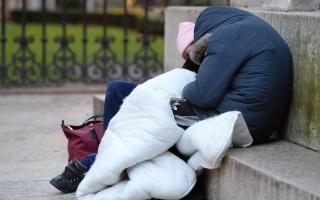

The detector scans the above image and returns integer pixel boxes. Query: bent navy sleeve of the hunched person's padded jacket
[183,31,248,108]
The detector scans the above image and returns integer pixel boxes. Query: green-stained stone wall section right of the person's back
[252,11,320,150]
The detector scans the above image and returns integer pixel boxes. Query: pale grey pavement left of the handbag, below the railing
[0,94,102,200]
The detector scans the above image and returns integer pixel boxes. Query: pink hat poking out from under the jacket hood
[177,22,194,57]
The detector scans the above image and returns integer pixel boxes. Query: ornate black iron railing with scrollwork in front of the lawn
[0,0,210,87]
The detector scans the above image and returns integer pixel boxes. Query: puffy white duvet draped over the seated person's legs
[77,69,252,200]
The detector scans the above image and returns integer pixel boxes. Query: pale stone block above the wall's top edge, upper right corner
[263,0,320,11]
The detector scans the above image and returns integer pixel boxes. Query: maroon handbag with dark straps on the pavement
[61,115,104,162]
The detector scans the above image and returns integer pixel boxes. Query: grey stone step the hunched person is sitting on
[93,95,320,200]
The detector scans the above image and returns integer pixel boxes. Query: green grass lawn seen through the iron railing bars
[6,22,164,66]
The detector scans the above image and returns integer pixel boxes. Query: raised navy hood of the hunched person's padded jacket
[194,7,251,41]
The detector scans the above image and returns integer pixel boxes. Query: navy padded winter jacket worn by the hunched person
[184,7,292,143]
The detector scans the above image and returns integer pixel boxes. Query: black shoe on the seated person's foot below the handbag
[50,160,88,193]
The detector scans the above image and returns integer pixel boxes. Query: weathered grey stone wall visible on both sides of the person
[164,5,320,150]
